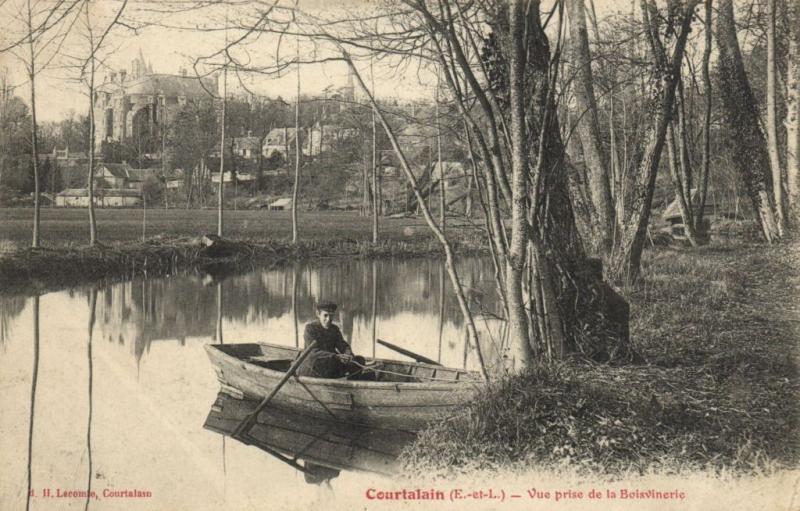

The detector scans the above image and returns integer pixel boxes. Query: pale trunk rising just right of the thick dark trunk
[567,0,615,256]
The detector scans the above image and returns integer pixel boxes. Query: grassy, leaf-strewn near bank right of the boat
[404,245,800,474]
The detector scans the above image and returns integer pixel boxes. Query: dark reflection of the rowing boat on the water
[204,392,415,482]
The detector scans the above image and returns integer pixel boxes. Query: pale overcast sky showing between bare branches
[0,0,631,121]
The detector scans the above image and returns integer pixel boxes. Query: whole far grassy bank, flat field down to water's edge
[0,208,482,294]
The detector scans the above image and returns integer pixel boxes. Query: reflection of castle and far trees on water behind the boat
[86,260,495,367]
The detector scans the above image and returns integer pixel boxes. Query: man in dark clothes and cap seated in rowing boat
[297,301,365,379]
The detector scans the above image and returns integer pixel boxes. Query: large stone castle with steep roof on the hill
[94,51,217,152]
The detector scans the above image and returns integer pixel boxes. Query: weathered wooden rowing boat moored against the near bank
[206,344,482,431]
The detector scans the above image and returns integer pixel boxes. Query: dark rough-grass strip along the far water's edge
[0,236,483,295]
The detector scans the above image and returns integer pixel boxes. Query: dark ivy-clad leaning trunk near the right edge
[717,0,780,243]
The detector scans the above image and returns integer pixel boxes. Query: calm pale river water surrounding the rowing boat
[0,259,498,509]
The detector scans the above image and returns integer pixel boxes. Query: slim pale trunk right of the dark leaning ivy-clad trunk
[767,0,785,236]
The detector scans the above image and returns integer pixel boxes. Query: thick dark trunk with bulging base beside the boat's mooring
[527,19,632,361]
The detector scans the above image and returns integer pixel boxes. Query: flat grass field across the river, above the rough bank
[0,208,450,247]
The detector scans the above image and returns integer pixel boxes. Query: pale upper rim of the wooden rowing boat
[204,343,484,391]
